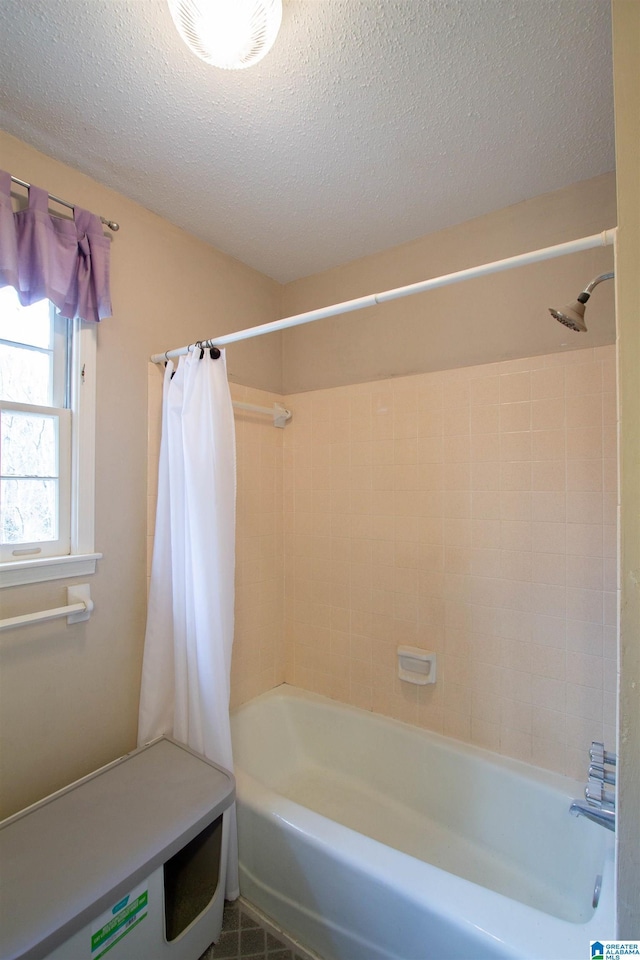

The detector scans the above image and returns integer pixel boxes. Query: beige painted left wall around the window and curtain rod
[0,133,281,815]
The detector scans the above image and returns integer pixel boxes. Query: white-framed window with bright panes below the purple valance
[0,287,98,586]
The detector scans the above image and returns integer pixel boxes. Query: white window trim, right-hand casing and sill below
[0,320,102,588]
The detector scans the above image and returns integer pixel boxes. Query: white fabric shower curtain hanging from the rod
[138,351,238,899]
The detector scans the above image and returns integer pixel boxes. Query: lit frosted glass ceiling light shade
[168,0,282,70]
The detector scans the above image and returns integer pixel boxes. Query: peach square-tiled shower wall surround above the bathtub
[150,346,617,779]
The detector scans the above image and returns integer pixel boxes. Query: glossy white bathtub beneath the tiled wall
[232,685,614,960]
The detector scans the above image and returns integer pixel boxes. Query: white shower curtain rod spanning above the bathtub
[151,227,616,363]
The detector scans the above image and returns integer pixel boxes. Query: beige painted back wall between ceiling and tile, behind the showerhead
[283,174,616,393]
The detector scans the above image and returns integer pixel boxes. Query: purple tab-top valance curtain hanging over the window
[0,170,111,321]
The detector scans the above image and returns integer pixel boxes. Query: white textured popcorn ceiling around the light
[0,0,614,282]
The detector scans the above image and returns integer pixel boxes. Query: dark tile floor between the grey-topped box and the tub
[200,900,312,960]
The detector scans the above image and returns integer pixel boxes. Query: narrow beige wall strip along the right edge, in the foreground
[612,0,640,940]
